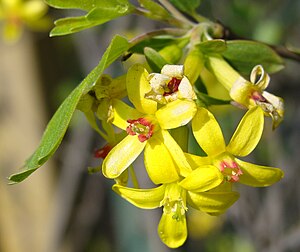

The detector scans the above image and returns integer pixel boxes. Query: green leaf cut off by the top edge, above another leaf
[45,0,129,11]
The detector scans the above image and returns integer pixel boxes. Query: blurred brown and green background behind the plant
[0,0,300,252]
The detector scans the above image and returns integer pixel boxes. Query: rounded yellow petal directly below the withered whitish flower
[155,99,197,129]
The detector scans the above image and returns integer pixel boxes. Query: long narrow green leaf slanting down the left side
[9,35,129,183]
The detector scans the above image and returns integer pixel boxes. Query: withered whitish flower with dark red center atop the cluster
[145,65,197,104]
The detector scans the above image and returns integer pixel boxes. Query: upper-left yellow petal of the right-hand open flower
[192,108,225,156]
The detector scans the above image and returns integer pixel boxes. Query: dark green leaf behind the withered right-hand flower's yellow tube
[222,40,284,75]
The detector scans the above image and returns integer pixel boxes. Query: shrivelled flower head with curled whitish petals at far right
[230,65,284,128]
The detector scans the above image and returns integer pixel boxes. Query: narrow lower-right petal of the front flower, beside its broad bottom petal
[161,130,192,177]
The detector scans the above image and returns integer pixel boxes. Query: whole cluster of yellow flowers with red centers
[80,61,283,248]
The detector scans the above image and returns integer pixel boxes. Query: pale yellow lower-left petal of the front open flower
[102,135,147,178]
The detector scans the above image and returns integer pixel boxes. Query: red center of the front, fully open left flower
[126,118,154,142]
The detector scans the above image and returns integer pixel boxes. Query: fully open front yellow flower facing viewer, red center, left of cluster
[102,65,197,184]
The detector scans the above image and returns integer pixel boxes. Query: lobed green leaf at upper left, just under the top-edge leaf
[50,1,133,37]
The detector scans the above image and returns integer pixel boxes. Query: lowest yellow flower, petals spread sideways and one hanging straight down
[113,177,239,248]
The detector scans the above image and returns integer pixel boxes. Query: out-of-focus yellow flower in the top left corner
[0,0,50,42]
